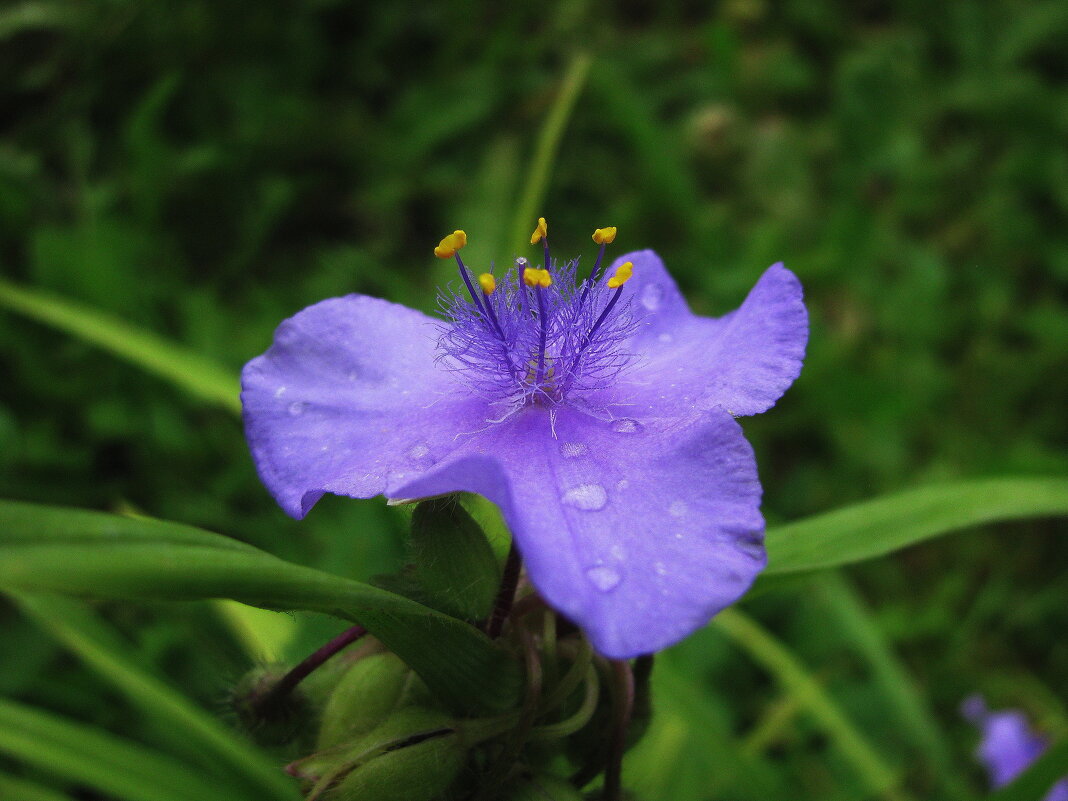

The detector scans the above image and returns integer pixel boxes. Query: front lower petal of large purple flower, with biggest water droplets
[391,407,766,659]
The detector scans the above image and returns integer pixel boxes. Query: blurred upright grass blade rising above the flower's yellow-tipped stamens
[512,52,593,252]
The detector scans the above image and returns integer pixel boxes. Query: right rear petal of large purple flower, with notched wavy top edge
[613,250,808,415]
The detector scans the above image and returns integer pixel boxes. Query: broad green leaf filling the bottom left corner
[0,698,234,801]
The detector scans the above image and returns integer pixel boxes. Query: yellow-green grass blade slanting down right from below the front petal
[712,609,909,801]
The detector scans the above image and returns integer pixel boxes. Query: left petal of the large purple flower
[241,295,489,518]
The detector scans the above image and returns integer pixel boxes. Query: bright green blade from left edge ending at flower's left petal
[0,279,241,414]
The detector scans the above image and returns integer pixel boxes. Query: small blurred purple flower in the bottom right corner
[961,695,1068,801]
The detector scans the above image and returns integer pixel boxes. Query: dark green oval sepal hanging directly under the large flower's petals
[411,498,501,621]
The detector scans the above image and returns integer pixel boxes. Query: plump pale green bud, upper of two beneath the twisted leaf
[318,653,426,751]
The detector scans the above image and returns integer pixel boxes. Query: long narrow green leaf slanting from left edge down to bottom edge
[13,593,297,799]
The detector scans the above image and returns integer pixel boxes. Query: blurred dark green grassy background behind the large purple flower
[0,0,1068,801]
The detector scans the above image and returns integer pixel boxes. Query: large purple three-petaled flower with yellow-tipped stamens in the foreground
[241,219,808,658]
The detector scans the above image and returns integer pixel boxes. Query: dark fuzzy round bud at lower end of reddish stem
[230,664,312,745]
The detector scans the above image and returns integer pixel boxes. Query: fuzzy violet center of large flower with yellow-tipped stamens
[435,218,638,413]
